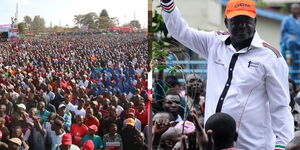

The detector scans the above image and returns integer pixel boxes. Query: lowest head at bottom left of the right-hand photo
[159,127,181,150]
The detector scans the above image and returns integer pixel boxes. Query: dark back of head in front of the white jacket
[205,113,238,149]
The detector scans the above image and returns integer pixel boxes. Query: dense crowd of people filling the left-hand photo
[0,32,149,150]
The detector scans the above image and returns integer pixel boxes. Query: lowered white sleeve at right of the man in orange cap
[266,57,294,149]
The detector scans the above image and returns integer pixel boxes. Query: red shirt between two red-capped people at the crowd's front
[71,123,88,147]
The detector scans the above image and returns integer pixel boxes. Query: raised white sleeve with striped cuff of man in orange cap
[161,0,216,59]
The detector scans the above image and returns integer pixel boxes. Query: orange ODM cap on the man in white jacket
[225,0,256,19]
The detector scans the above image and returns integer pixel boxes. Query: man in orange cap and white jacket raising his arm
[161,0,294,150]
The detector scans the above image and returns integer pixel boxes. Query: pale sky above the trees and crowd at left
[0,0,148,27]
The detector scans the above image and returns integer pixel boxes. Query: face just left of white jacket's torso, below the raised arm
[186,74,202,99]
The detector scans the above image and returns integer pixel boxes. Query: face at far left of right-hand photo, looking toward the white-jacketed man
[162,90,180,118]
